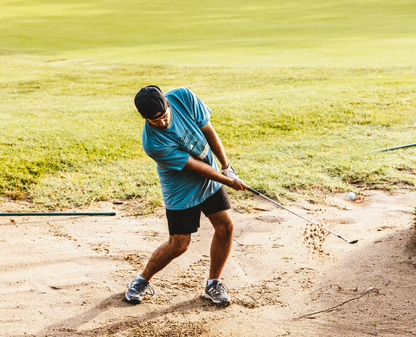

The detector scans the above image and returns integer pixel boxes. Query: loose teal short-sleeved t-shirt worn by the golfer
[142,88,221,210]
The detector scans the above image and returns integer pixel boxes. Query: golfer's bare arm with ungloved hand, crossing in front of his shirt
[184,156,249,191]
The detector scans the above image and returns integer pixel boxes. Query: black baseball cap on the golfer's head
[134,85,168,119]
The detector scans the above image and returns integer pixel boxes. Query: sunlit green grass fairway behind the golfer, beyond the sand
[0,0,416,209]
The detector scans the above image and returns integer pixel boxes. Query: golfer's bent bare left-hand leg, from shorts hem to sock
[140,234,191,281]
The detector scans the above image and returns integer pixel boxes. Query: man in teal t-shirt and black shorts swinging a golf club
[126,85,248,305]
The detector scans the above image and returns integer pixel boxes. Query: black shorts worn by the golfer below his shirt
[166,186,231,235]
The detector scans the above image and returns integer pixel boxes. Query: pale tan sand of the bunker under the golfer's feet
[0,191,416,337]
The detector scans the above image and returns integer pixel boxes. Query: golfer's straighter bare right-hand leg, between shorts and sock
[208,209,234,280]
